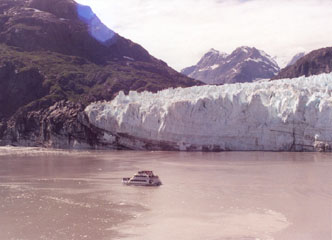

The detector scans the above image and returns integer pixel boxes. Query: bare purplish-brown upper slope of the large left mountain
[0,0,157,63]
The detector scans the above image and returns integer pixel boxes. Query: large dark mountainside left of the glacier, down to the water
[0,0,202,147]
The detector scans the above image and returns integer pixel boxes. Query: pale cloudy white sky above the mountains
[77,0,332,71]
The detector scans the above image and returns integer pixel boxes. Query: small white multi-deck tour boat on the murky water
[122,171,161,186]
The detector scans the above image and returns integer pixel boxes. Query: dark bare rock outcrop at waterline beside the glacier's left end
[0,100,121,149]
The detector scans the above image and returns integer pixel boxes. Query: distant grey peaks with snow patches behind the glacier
[181,47,280,84]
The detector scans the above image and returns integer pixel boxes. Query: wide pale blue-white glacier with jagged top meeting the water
[85,73,332,151]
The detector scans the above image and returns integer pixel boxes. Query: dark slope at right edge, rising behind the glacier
[273,47,332,79]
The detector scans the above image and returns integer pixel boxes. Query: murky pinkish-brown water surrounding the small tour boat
[0,148,332,240]
